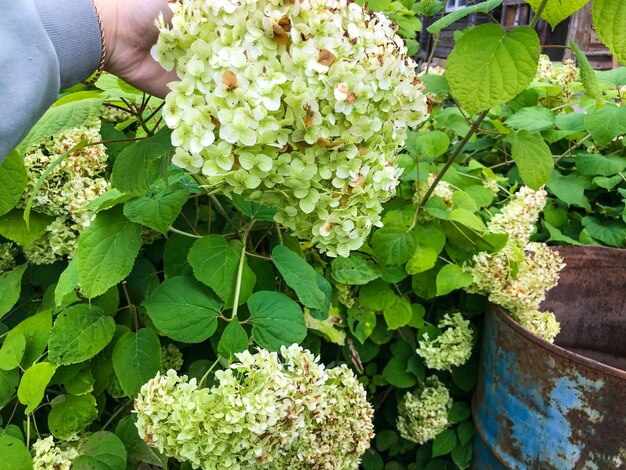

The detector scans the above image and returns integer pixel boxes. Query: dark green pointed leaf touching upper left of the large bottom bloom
[113,328,161,397]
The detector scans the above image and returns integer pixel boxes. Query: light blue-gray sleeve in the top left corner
[0,0,101,162]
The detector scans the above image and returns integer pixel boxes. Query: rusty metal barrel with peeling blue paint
[472,247,626,470]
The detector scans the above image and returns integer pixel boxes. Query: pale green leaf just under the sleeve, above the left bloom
[17,98,104,154]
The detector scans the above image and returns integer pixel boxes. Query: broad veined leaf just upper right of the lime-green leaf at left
[48,304,115,365]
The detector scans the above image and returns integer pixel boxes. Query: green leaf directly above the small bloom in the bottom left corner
[48,393,98,440]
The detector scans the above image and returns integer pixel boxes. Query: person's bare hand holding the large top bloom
[95,0,178,98]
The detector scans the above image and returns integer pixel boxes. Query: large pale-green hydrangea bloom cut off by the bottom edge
[135,345,373,469]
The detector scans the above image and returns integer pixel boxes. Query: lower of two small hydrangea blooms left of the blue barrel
[396,375,452,444]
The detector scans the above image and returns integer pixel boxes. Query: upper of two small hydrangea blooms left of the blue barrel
[417,312,474,371]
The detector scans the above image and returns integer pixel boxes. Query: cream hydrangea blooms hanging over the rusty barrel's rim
[466,187,565,341]
